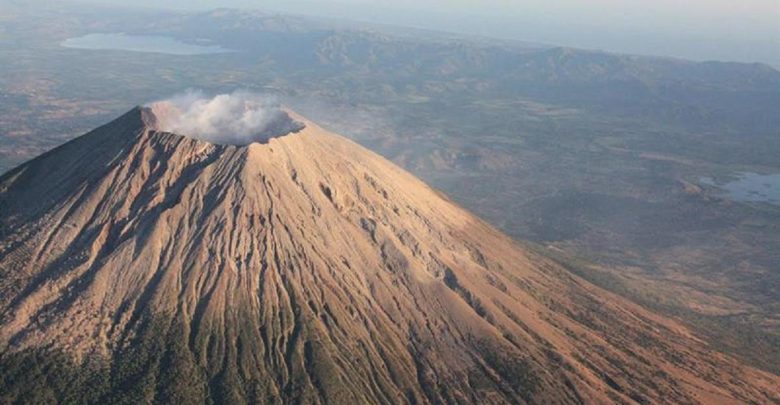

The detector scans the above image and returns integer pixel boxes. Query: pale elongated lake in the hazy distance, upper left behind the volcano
[60,33,233,55]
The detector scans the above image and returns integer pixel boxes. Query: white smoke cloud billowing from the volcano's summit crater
[147,90,304,145]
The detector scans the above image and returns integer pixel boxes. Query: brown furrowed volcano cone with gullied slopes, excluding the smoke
[0,108,780,403]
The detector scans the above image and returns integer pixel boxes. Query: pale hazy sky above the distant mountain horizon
[96,0,780,66]
